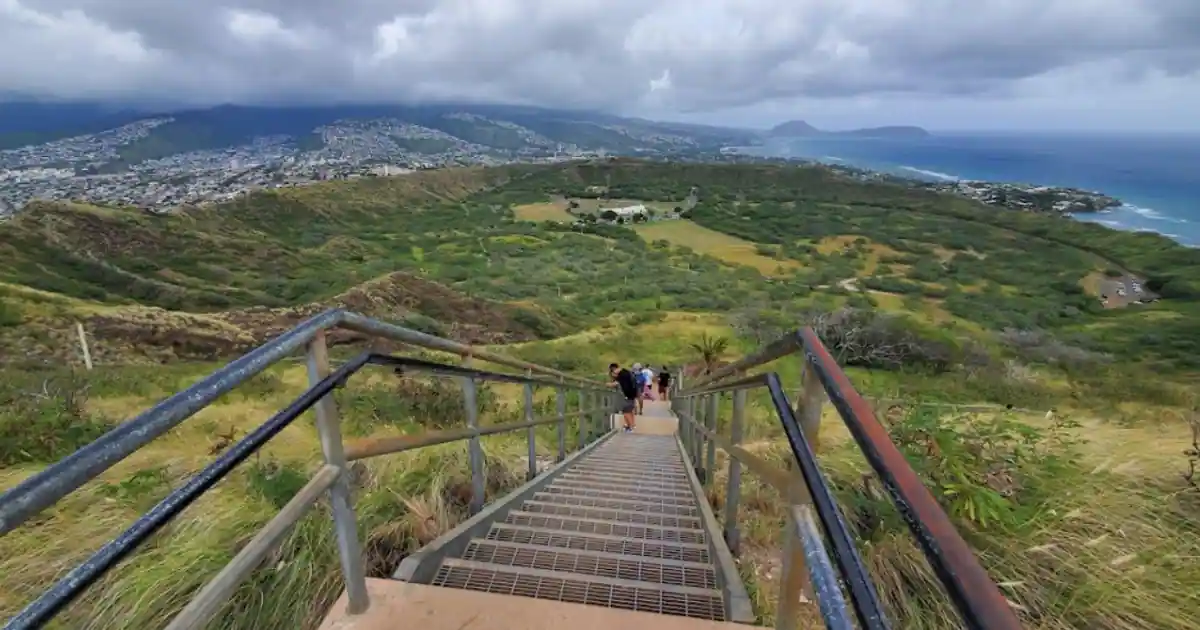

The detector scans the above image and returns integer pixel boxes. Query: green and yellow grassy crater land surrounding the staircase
[0,160,1200,630]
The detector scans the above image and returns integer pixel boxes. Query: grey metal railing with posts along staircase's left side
[0,310,616,630]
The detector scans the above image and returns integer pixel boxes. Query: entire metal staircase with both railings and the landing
[0,310,1020,630]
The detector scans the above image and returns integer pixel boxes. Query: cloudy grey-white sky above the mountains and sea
[0,0,1200,131]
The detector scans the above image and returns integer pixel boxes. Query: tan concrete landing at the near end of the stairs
[320,580,746,630]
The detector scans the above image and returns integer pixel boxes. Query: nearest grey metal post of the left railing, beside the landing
[306,330,371,614]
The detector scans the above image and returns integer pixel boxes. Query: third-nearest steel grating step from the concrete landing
[487,523,709,563]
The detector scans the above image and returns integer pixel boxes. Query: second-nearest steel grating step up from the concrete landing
[462,539,716,589]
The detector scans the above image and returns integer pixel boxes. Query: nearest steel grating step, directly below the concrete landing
[433,559,725,620]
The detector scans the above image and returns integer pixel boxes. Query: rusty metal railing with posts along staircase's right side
[672,328,1021,630]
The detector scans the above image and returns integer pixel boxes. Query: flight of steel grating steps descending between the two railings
[397,433,752,620]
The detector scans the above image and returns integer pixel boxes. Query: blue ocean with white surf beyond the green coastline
[755,133,1200,247]
